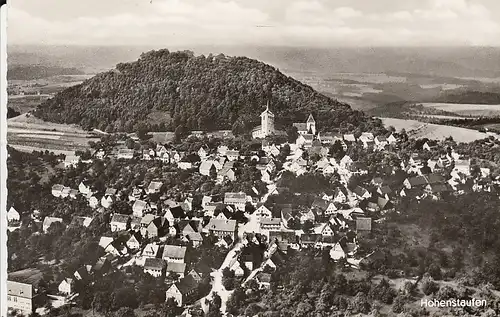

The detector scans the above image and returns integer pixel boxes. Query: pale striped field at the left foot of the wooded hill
[7,114,99,154]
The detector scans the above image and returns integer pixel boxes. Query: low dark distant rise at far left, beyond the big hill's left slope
[7,65,85,80]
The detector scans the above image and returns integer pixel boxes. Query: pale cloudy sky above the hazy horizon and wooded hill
[8,0,500,47]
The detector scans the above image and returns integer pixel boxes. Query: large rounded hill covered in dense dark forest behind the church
[35,49,366,131]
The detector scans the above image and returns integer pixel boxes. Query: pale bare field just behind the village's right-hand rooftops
[380,118,489,142]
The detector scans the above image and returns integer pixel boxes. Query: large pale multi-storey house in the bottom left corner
[6,278,38,316]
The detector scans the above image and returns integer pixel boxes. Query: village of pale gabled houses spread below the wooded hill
[7,105,500,315]
